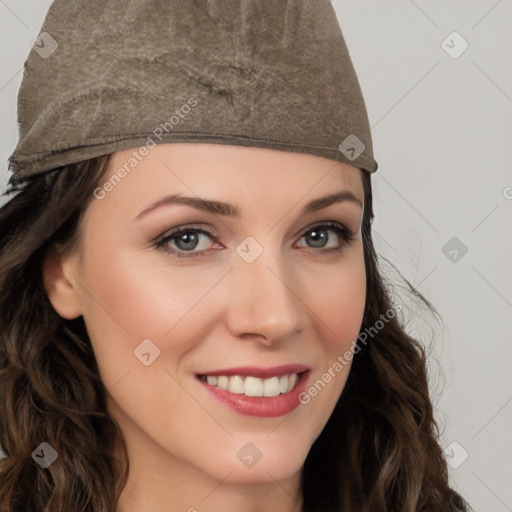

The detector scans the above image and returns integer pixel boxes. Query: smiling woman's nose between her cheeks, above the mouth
[227,246,304,346]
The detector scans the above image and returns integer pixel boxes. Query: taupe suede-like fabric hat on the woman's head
[10,0,378,179]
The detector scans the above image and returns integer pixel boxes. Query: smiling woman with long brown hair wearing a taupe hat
[0,0,472,512]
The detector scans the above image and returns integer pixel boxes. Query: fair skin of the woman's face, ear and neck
[44,143,366,512]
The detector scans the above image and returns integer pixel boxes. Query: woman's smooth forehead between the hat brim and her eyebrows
[103,143,365,200]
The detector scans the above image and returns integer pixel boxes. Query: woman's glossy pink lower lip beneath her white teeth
[196,370,311,418]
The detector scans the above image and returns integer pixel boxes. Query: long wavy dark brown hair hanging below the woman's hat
[0,156,467,512]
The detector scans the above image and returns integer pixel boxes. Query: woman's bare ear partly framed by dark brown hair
[42,246,82,320]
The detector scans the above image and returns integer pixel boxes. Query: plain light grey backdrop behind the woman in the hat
[0,0,512,512]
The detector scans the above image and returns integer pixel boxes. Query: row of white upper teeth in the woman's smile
[201,373,298,397]
